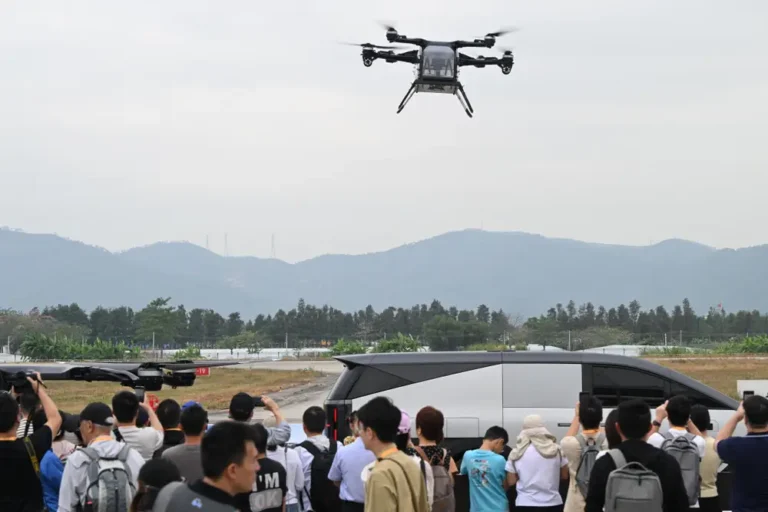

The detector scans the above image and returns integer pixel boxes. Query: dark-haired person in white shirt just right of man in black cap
[112,391,164,461]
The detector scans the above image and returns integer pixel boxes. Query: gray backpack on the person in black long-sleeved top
[605,449,664,512]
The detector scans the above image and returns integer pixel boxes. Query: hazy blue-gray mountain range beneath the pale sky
[0,230,768,317]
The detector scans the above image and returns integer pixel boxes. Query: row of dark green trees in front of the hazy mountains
[0,298,768,350]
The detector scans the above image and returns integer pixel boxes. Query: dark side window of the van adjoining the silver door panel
[592,365,667,407]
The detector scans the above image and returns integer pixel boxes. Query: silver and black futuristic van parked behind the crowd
[325,352,743,456]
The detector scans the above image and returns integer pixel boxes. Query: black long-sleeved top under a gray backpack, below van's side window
[584,439,690,512]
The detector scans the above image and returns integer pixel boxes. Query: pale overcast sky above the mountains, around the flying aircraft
[0,0,768,261]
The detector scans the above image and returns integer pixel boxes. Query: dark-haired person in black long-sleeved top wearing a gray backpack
[584,399,690,512]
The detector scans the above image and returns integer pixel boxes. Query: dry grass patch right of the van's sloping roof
[648,357,768,399]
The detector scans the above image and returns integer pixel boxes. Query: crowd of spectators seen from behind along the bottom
[0,375,768,512]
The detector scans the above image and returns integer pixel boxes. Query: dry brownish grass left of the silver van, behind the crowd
[48,368,321,412]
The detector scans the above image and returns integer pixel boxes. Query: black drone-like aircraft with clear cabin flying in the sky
[345,25,515,117]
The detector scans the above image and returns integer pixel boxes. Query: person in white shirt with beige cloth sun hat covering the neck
[505,414,569,512]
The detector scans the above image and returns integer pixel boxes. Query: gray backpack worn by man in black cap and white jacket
[81,445,136,512]
